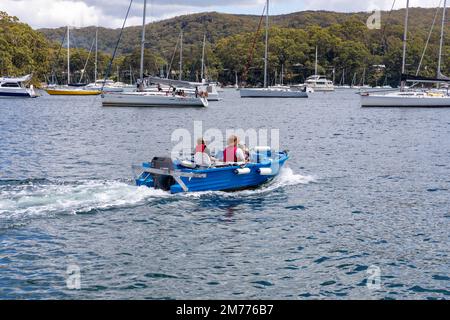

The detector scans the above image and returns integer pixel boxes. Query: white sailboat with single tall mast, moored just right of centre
[239,0,308,98]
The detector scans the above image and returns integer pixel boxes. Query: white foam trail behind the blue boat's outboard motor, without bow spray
[0,180,169,218]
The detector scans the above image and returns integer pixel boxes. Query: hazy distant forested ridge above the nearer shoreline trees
[38,8,442,53]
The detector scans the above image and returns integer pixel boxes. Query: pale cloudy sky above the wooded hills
[0,0,442,28]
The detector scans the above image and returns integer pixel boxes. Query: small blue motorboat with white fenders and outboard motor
[134,147,289,193]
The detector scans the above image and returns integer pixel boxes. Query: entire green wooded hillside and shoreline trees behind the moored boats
[0,8,450,85]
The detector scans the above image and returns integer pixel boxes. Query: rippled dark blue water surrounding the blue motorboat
[0,90,450,299]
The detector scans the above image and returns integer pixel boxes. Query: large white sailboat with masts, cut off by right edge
[361,0,450,107]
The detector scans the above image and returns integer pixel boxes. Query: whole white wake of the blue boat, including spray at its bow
[0,168,314,227]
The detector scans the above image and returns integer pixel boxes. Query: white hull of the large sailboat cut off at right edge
[361,94,450,107]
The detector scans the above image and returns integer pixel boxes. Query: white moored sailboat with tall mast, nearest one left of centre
[102,0,208,107]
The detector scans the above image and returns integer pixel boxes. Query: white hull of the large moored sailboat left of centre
[102,92,208,107]
